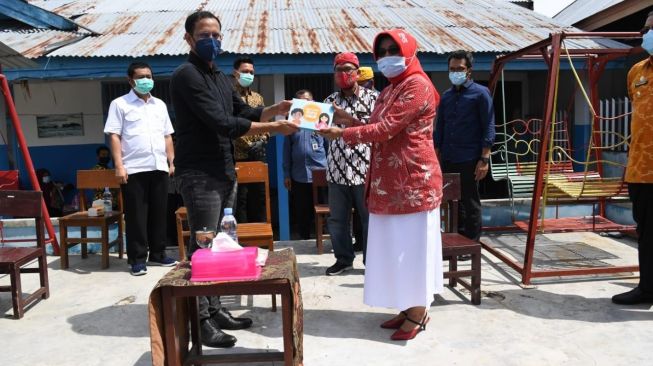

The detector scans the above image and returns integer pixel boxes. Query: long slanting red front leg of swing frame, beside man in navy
[522,33,562,285]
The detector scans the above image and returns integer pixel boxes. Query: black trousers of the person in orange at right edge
[628,183,653,293]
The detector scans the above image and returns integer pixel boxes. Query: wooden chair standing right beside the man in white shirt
[59,169,125,269]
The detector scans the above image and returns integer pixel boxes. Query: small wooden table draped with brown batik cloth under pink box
[149,249,303,366]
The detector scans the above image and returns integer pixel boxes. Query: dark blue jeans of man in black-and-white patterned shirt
[327,183,369,265]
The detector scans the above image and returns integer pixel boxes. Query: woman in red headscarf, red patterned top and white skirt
[320,29,443,340]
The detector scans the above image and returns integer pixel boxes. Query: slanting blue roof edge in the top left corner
[0,0,77,31]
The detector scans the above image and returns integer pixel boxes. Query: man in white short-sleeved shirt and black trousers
[104,62,176,276]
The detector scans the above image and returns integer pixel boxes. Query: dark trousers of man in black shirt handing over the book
[175,171,238,320]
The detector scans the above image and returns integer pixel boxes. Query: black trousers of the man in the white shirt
[121,170,168,264]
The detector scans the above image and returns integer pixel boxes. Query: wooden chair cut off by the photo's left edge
[0,191,50,319]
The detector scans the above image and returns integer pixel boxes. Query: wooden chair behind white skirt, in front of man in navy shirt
[441,173,481,305]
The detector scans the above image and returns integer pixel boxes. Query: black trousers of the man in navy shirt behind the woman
[442,160,482,240]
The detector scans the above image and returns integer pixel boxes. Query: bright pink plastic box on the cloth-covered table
[190,247,261,282]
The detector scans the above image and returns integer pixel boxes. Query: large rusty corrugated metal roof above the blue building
[0,0,619,57]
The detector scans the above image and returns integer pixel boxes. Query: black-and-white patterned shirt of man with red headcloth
[324,87,379,186]
